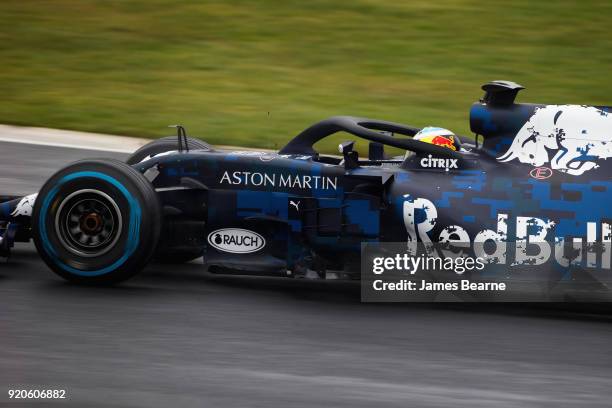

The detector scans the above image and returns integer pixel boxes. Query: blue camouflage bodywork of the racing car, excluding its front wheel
[0,81,612,277]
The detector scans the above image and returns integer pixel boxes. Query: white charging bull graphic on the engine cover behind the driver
[498,105,612,176]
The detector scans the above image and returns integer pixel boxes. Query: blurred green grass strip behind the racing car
[0,0,612,152]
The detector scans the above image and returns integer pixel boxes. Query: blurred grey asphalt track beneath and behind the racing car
[0,143,612,408]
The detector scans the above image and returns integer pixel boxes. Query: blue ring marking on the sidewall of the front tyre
[38,171,142,276]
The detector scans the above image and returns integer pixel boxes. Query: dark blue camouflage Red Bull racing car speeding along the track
[0,81,612,284]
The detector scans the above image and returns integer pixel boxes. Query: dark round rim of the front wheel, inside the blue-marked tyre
[55,189,123,257]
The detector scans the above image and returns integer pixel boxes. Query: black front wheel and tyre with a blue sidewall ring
[32,160,162,284]
